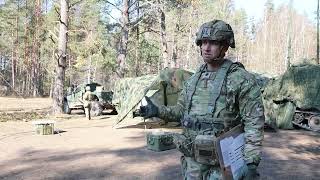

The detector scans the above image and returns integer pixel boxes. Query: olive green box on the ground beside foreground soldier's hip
[147,131,176,151]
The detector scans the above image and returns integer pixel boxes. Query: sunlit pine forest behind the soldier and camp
[0,0,318,111]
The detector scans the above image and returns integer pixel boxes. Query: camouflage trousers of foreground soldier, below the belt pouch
[181,156,222,180]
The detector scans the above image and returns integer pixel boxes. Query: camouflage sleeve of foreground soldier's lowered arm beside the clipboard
[239,75,264,165]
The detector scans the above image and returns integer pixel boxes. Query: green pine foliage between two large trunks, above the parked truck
[64,0,116,81]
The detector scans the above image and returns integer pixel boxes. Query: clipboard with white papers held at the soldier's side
[216,124,245,180]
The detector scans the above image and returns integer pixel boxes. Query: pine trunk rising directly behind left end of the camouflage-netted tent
[117,0,129,78]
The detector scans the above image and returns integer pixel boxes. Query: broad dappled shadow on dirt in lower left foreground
[0,147,181,179]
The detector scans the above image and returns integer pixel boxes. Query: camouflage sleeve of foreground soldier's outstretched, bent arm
[159,83,186,121]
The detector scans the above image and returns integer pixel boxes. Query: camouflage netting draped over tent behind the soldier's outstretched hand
[112,69,192,123]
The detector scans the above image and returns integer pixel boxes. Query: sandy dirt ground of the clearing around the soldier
[0,98,320,180]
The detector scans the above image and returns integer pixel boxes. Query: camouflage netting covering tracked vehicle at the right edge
[263,64,320,129]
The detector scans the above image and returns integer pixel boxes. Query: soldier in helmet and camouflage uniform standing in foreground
[140,20,264,180]
